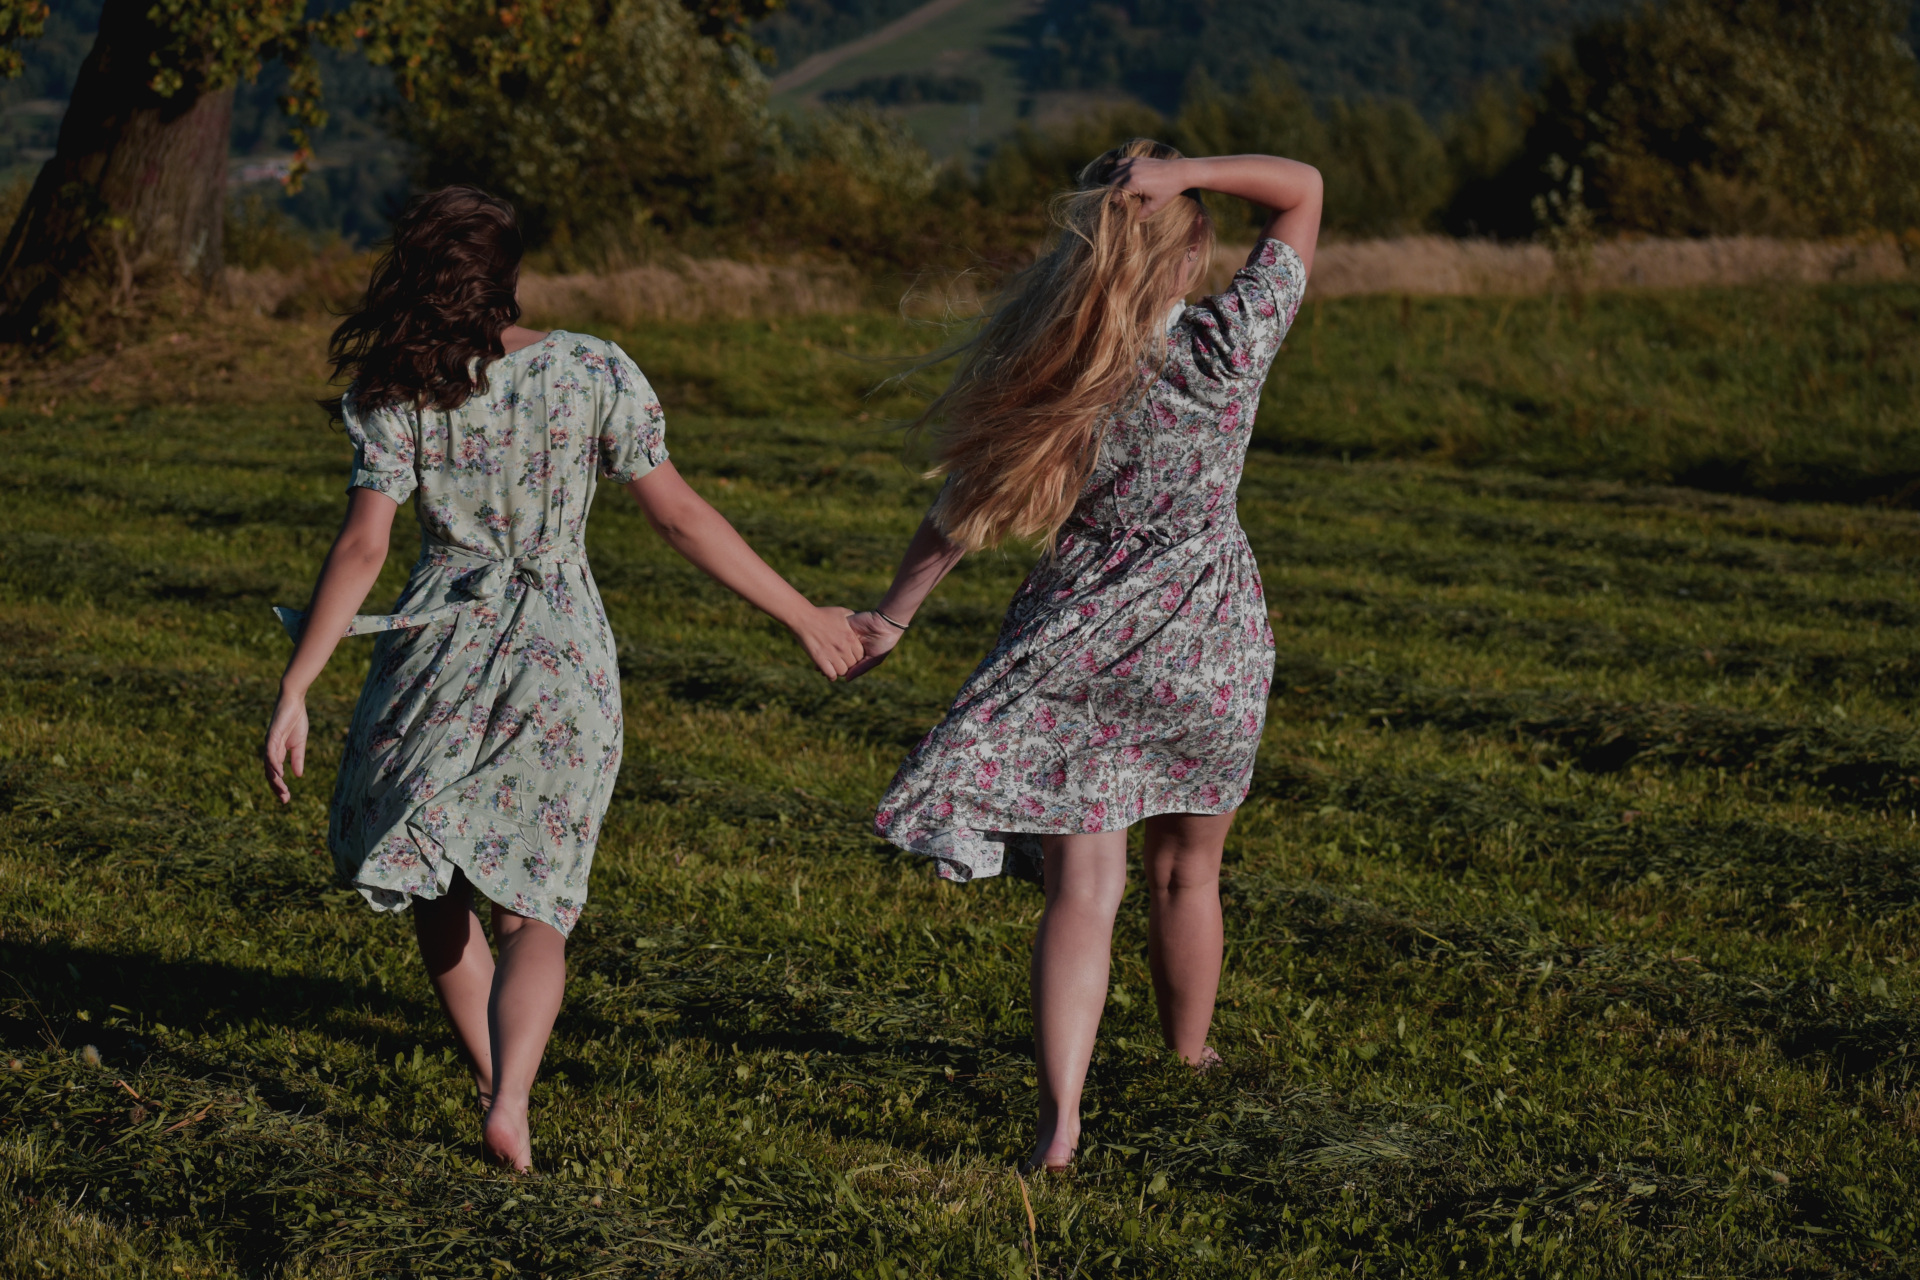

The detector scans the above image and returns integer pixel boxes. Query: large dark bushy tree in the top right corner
[1450,0,1920,234]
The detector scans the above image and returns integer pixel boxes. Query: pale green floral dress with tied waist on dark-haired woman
[280,330,666,935]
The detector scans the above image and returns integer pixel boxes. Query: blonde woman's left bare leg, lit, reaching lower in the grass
[1027,831,1127,1171]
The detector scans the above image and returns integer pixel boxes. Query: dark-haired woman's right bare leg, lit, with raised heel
[482,902,566,1173]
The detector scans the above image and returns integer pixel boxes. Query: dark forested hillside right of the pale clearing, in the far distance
[1027,0,1632,117]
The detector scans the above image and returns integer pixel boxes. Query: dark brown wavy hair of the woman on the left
[321,186,524,418]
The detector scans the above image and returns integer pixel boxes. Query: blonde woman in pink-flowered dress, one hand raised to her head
[852,138,1321,1169]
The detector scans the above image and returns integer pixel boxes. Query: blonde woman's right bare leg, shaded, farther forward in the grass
[1144,814,1235,1067]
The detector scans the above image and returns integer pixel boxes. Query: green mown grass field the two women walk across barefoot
[0,286,1920,1280]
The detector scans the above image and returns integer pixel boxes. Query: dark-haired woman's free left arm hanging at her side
[259,489,399,804]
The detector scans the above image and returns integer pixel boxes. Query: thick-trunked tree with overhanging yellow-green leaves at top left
[0,0,778,342]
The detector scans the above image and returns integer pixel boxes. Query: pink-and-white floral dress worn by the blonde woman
[874,240,1306,881]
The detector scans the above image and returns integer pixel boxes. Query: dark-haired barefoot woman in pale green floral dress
[261,186,860,1171]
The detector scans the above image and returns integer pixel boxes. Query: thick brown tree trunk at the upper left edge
[0,0,232,344]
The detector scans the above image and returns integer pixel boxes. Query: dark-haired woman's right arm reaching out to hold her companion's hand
[626,462,862,679]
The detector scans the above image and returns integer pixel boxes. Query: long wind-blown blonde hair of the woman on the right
[916,138,1213,551]
